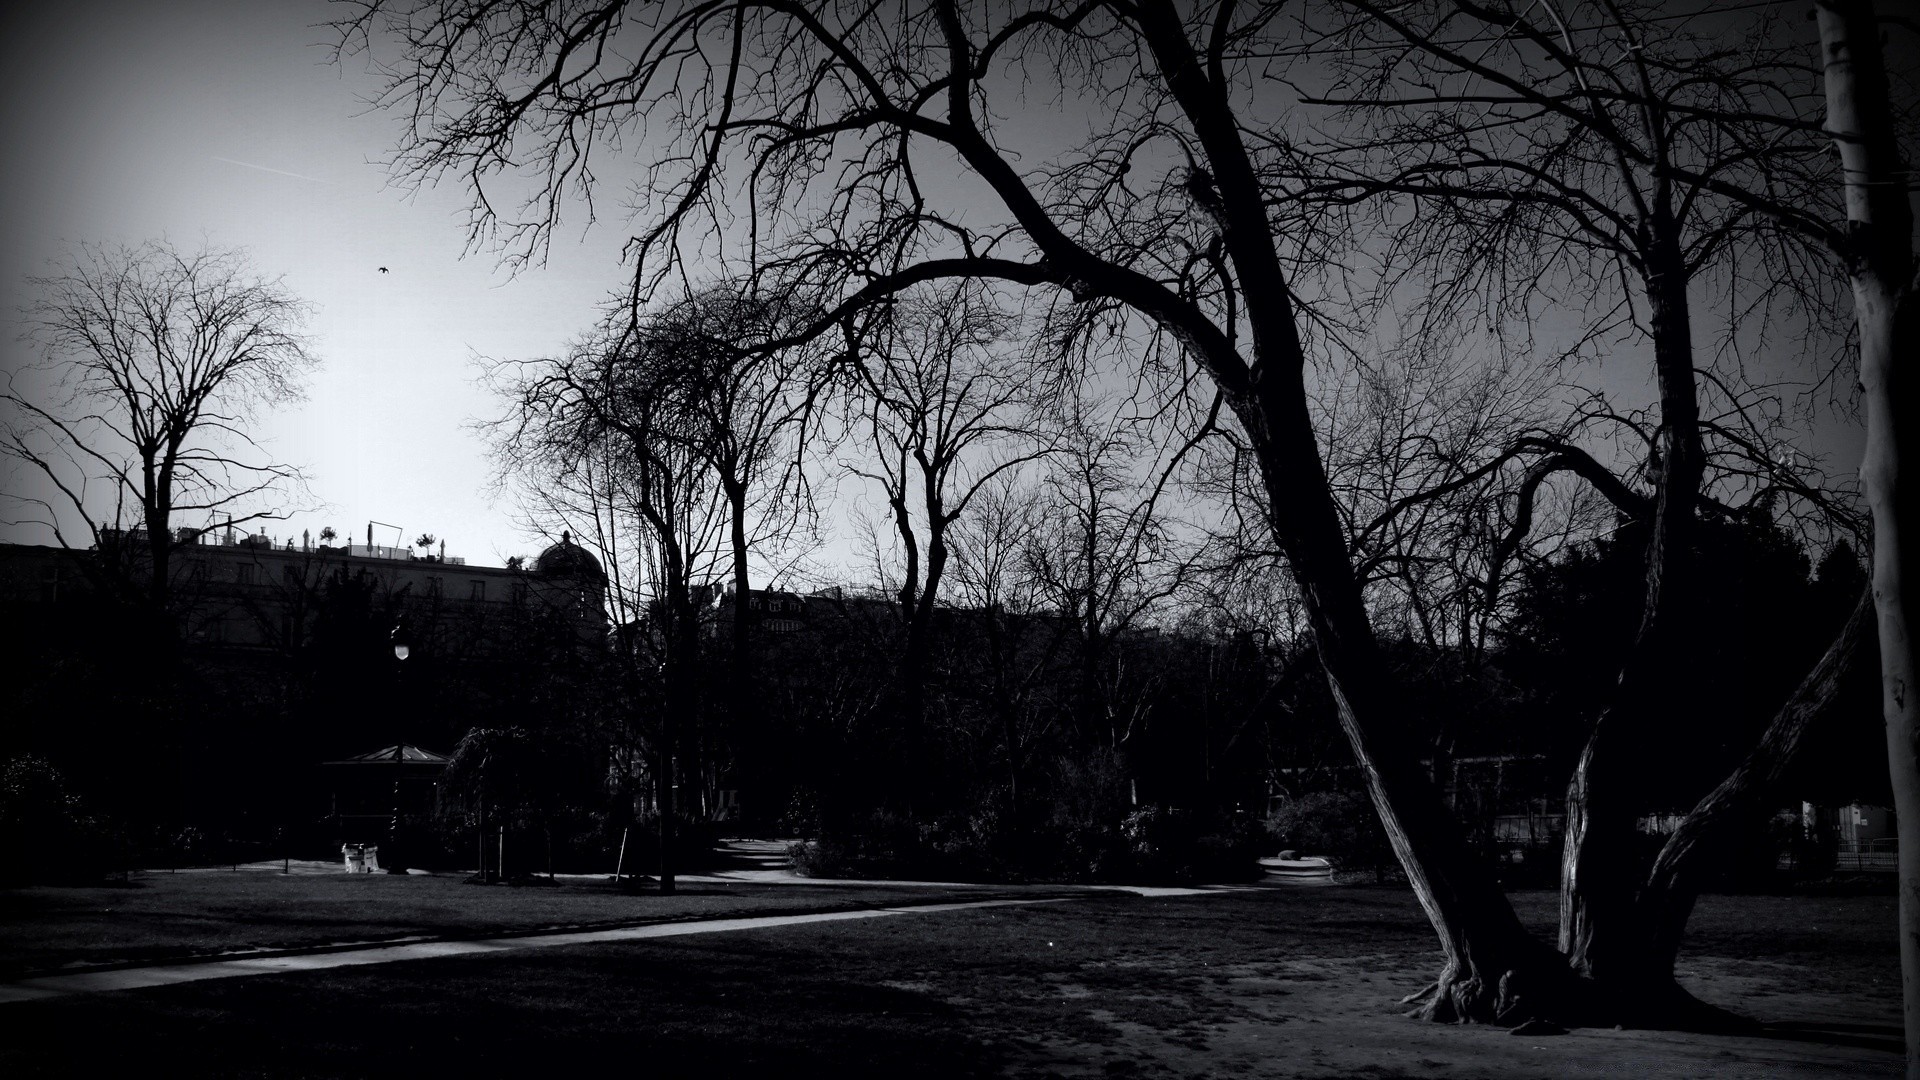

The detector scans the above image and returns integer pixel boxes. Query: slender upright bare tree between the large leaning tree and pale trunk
[1304,0,1873,1013]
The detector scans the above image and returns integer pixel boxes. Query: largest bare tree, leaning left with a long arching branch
[344,0,1873,1019]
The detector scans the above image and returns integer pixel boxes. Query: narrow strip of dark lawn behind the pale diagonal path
[0,871,1018,978]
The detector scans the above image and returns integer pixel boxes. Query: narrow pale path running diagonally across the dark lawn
[0,896,1071,1005]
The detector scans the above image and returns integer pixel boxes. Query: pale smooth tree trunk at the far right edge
[1818,0,1920,1078]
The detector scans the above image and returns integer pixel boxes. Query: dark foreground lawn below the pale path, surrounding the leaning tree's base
[0,874,1901,1080]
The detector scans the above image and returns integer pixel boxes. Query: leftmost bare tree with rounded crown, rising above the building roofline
[0,240,319,611]
